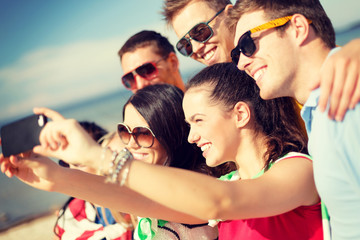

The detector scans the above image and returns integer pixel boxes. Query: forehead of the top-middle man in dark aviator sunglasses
[171,1,216,38]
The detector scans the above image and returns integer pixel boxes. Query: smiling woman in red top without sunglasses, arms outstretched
[0,63,323,240]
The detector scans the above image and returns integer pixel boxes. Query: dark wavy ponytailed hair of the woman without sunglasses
[186,63,308,169]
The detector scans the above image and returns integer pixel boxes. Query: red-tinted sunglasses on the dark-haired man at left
[121,58,165,90]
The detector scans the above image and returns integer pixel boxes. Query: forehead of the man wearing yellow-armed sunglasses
[234,10,267,46]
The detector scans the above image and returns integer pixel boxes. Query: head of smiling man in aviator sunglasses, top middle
[163,0,234,65]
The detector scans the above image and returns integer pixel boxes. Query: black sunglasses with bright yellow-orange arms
[231,16,311,65]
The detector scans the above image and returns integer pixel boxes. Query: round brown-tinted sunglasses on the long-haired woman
[117,123,155,148]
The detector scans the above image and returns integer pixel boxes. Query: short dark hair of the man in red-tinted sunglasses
[118,30,175,60]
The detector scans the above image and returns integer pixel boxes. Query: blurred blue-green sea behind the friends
[0,26,360,232]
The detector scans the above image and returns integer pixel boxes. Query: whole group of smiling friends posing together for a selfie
[0,0,360,240]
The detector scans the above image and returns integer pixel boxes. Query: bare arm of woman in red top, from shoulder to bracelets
[123,158,319,220]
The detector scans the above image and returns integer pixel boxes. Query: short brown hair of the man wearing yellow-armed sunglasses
[228,0,336,48]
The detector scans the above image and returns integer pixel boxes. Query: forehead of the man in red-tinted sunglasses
[121,45,161,73]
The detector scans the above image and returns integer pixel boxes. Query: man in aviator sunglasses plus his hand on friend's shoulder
[163,0,360,119]
